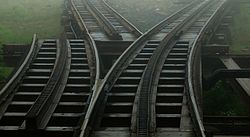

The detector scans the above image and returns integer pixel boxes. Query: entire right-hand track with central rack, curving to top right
[77,0,229,137]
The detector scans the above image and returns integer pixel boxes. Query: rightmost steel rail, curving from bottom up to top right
[187,1,228,137]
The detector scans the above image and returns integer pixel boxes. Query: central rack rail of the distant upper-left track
[83,0,122,40]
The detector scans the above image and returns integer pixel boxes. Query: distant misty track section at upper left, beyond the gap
[67,0,142,41]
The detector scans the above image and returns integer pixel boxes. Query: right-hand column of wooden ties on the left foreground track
[43,40,93,137]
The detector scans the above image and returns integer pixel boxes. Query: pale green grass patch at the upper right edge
[230,3,250,54]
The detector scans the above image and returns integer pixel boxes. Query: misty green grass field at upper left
[0,0,64,81]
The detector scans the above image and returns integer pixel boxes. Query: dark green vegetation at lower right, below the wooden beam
[203,81,250,116]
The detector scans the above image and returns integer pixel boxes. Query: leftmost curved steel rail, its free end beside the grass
[0,34,37,104]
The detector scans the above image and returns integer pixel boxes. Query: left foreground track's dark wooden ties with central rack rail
[0,39,99,137]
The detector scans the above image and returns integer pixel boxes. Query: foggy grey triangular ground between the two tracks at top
[107,0,191,32]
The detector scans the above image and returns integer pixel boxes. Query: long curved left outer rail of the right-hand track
[77,2,200,137]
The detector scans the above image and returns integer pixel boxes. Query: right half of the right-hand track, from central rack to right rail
[137,1,229,137]
